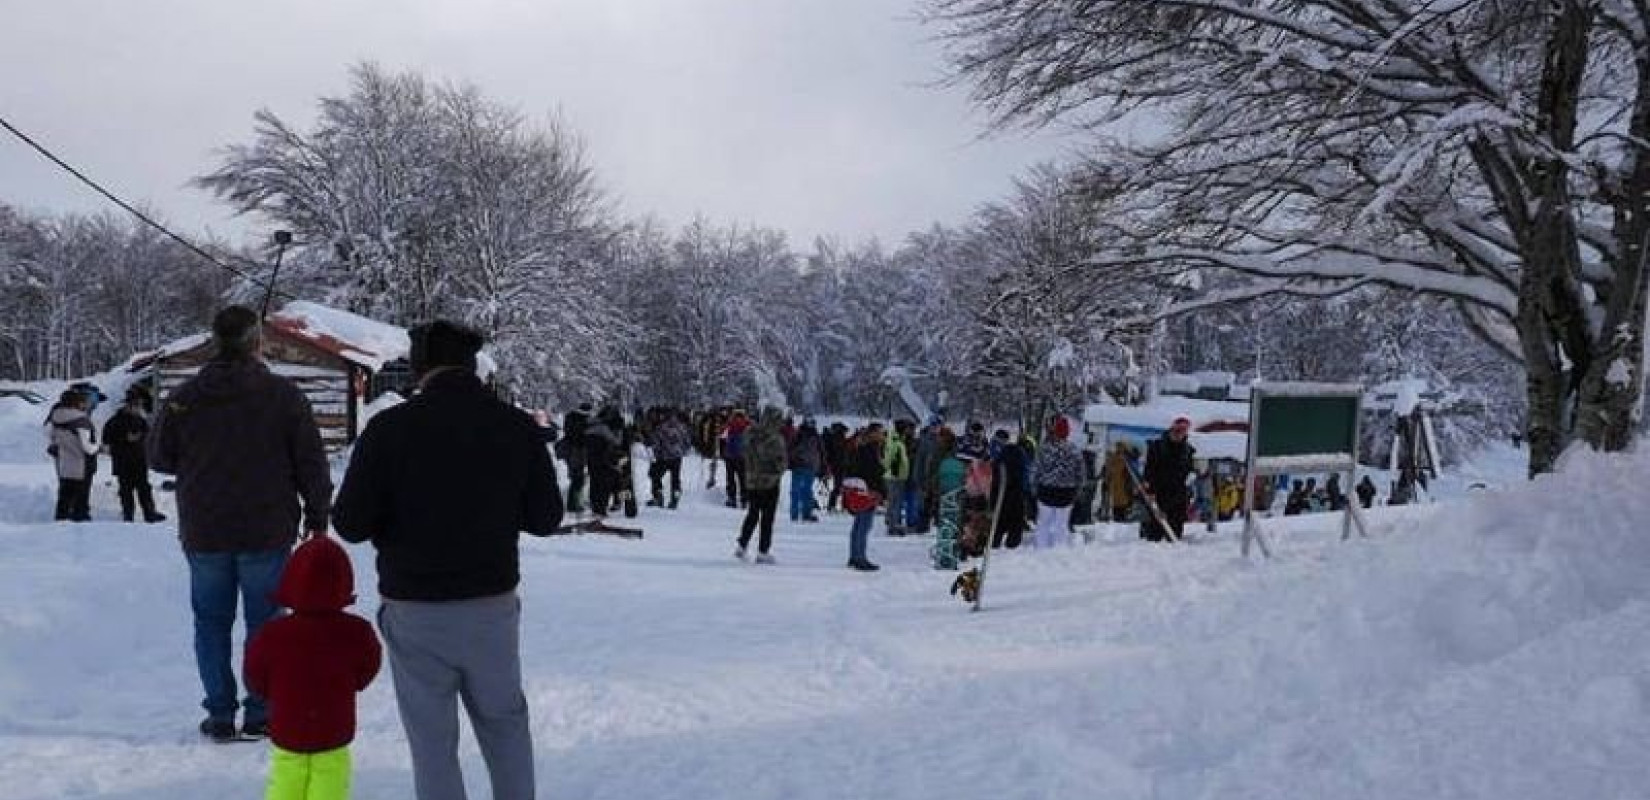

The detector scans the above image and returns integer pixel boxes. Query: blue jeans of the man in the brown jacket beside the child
[185,548,289,722]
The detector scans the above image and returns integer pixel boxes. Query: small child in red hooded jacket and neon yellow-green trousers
[246,536,381,800]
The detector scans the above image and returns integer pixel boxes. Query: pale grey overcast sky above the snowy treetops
[0,0,1066,247]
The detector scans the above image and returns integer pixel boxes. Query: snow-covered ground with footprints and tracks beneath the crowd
[0,394,1650,800]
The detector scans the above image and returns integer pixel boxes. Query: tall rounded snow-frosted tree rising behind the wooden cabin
[196,64,635,399]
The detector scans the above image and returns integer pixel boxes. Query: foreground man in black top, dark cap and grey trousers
[333,322,561,800]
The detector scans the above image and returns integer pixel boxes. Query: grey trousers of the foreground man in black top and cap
[378,592,533,800]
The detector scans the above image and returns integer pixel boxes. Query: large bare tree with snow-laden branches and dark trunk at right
[926,0,1650,472]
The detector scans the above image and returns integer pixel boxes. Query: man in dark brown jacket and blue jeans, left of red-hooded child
[149,305,332,741]
